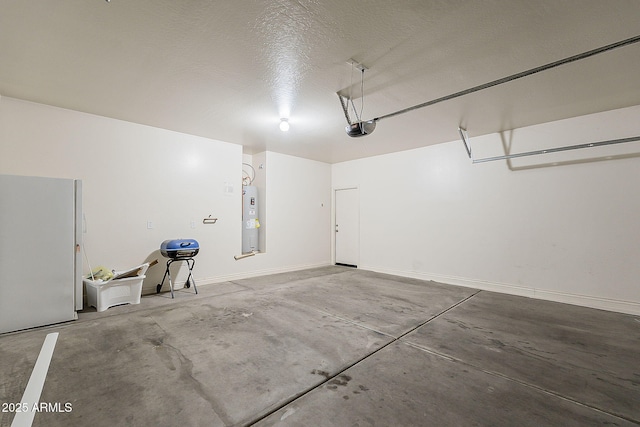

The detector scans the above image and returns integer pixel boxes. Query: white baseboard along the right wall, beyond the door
[361,266,640,315]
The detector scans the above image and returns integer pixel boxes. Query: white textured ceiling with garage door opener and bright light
[0,0,640,163]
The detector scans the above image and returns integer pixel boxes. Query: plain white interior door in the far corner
[334,188,360,267]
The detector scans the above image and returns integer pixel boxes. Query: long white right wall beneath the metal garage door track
[332,107,640,314]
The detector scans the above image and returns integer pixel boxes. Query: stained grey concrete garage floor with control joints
[0,267,640,427]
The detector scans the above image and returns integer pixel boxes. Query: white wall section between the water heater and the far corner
[238,152,331,274]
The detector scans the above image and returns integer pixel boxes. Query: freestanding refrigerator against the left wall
[0,175,82,333]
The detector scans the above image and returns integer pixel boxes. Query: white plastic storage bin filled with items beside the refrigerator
[84,264,149,312]
